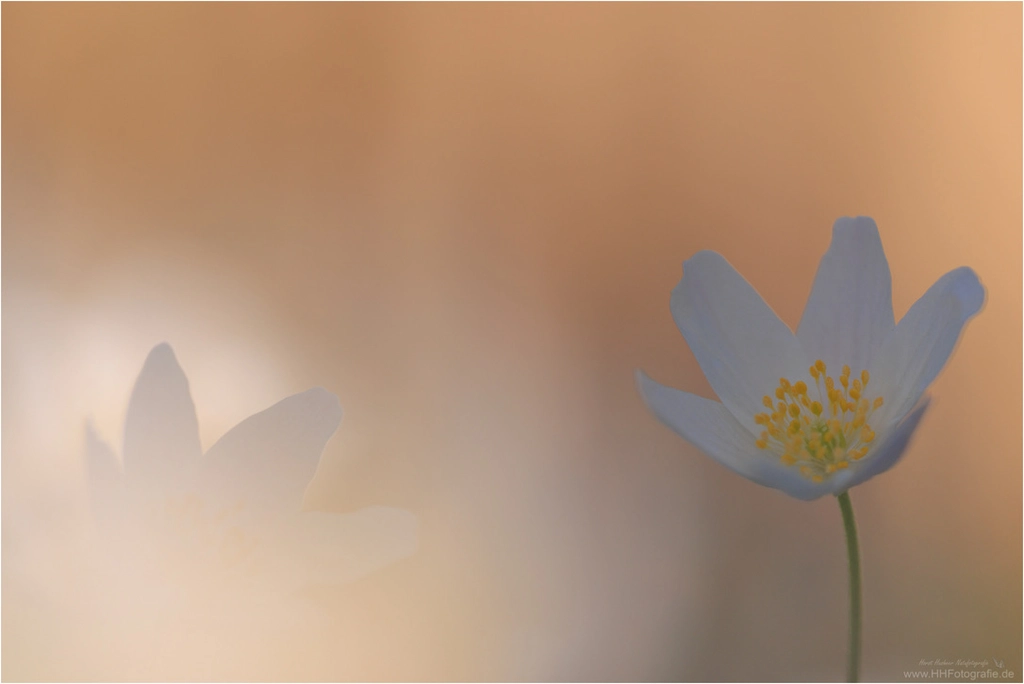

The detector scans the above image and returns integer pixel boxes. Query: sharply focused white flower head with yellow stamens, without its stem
[637,217,985,501]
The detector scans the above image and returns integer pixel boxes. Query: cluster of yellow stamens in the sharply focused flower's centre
[754,359,883,482]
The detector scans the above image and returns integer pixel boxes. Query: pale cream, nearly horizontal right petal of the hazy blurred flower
[260,506,419,590]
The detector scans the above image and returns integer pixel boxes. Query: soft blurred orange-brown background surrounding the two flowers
[2,3,1024,681]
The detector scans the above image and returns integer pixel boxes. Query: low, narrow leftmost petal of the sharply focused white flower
[637,371,829,501]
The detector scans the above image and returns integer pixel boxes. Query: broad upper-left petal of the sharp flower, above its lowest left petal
[672,251,813,431]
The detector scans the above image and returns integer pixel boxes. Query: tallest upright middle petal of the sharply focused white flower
[797,216,896,373]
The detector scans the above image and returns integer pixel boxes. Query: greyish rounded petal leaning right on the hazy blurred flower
[200,387,341,517]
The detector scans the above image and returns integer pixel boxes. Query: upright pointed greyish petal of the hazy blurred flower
[123,343,202,496]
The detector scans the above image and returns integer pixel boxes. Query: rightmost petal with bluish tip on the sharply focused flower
[870,266,985,426]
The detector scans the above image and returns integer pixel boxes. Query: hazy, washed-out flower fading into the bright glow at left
[80,344,417,602]
